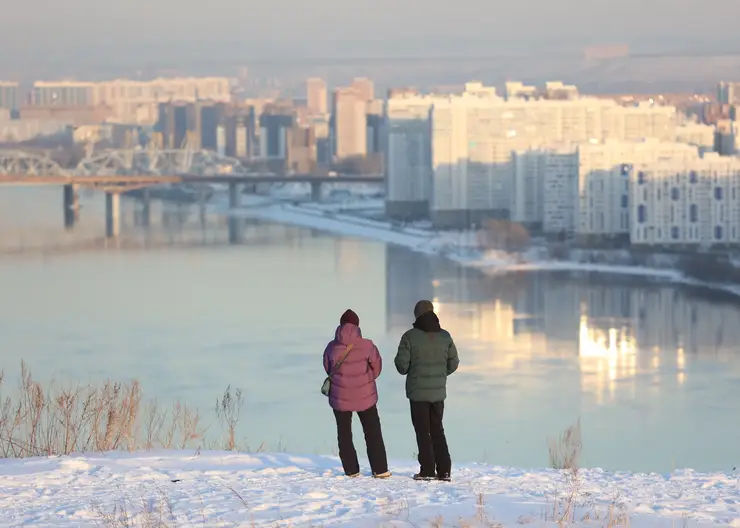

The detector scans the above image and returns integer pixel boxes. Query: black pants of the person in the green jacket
[411,401,452,477]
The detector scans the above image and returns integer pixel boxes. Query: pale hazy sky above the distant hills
[0,0,740,65]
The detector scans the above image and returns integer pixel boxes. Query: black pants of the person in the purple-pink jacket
[334,405,388,475]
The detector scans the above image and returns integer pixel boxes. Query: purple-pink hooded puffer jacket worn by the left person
[324,323,383,412]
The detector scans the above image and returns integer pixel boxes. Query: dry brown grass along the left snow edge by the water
[0,363,243,458]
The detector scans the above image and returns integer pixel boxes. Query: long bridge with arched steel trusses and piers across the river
[0,148,385,243]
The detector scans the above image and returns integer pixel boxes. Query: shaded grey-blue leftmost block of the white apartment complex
[384,92,434,218]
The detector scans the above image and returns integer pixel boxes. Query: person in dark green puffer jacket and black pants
[395,301,460,481]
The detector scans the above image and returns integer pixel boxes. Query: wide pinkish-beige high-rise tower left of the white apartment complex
[332,88,367,160]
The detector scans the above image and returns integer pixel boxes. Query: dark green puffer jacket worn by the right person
[395,312,460,402]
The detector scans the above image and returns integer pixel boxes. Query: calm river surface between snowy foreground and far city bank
[0,189,740,471]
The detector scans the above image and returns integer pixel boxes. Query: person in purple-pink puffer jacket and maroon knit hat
[324,310,391,478]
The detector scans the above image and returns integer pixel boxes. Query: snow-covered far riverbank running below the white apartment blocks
[211,190,740,297]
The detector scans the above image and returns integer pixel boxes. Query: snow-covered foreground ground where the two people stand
[0,451,740,528]
